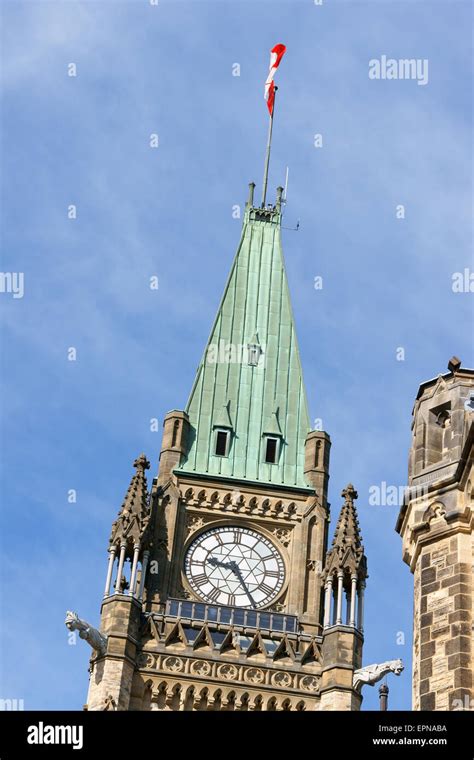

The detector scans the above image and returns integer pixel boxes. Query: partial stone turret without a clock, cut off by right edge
[397,357,474,710]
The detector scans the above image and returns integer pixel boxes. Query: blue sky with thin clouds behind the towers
[0,0,474,709]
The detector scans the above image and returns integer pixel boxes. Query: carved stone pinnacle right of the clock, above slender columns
[326,483,367,578]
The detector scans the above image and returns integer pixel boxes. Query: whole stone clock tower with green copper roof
[83,183,367,710]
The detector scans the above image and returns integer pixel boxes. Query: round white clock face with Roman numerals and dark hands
[184,526,285,609]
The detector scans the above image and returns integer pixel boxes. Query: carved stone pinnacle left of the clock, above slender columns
[110,454,150,553]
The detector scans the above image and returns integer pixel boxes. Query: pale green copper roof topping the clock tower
[179,183,310,488]
